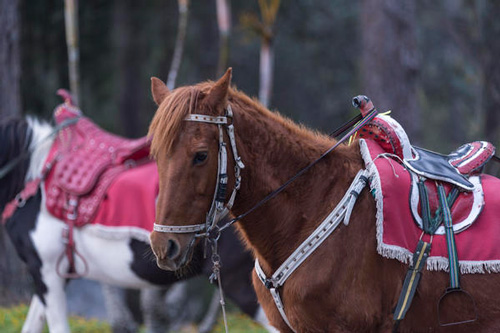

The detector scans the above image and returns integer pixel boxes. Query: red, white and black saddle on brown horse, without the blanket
[358,115,495,234]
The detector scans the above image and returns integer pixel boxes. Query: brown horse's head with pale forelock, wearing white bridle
[149,70,240,270]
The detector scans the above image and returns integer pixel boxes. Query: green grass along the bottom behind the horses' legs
[0,304,266,333]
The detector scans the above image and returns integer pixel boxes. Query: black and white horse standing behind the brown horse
[0,117,273,332]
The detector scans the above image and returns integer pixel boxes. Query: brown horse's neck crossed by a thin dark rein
[233,98,362,270]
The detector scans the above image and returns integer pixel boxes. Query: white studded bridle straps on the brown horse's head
[153,105,245,238]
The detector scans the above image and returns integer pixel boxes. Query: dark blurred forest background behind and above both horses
[0,0,500,330]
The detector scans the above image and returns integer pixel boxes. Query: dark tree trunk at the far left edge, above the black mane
[0,0,21,117]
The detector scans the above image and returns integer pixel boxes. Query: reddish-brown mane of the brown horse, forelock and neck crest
[148,81,332,158]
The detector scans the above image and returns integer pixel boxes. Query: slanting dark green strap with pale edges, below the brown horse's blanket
[394,240,431,322]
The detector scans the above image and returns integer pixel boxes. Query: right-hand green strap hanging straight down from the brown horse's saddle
[438,184,460,289]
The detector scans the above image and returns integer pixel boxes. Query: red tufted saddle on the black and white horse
[45,100,150,227]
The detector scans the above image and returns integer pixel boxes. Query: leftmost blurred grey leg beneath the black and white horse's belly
[101,283,137,332]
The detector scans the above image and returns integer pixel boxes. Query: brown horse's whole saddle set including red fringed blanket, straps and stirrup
[358,100,499,324]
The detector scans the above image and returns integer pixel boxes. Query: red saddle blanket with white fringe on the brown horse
[360,139,500,274]
